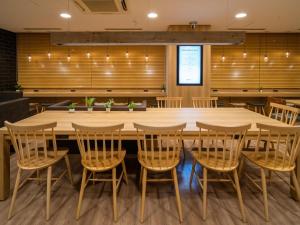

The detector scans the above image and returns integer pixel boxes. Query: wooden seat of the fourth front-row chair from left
[192,150,238,172]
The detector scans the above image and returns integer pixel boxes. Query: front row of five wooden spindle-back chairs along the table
[5,122,300,222]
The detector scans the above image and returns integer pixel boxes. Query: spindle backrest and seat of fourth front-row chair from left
[196,122,251,169]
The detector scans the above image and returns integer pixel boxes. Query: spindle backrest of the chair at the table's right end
[269,102,300,125]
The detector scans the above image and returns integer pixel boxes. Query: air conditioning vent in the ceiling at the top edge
[73,0,127,14]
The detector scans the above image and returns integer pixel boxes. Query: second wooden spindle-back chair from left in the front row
[72,123,128,221]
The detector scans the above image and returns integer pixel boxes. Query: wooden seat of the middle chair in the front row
[138,151,180,172]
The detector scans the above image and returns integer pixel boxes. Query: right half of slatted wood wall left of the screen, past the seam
[92,46,165,89]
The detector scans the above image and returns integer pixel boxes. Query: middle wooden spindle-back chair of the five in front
[134,123,186,222]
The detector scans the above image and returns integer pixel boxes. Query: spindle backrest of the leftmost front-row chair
[4,121,57,166]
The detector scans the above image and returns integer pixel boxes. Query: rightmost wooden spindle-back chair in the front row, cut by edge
[242,123,300,221]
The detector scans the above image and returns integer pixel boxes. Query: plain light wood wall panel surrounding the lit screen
[167,45,210,107]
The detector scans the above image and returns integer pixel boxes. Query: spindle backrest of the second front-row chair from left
[72,123,124,164]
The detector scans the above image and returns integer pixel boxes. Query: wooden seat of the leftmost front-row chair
[18,149,69,170]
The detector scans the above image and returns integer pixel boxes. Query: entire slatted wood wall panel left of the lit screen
[17,34,166,89]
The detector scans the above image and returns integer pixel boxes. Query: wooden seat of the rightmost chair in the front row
[242,150,295,172]
